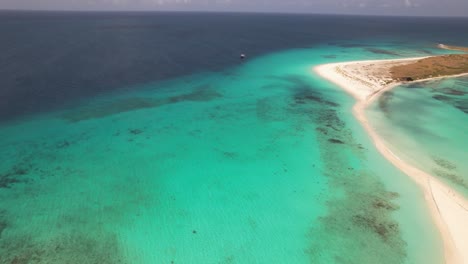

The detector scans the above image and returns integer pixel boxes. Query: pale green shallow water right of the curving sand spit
[368,76,468,196]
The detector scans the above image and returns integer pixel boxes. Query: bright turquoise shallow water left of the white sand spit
[0,44,443,263]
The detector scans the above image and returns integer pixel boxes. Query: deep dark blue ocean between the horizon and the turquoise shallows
[0,11,468,120]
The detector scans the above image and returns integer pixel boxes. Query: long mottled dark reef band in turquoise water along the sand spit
[289,82,406,264]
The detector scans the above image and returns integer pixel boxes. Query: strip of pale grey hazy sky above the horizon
[0,0,468,17]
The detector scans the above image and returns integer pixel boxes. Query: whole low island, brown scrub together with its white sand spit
[314,50,468,263]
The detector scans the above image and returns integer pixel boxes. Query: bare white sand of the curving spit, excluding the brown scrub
[314,58,468,264]
